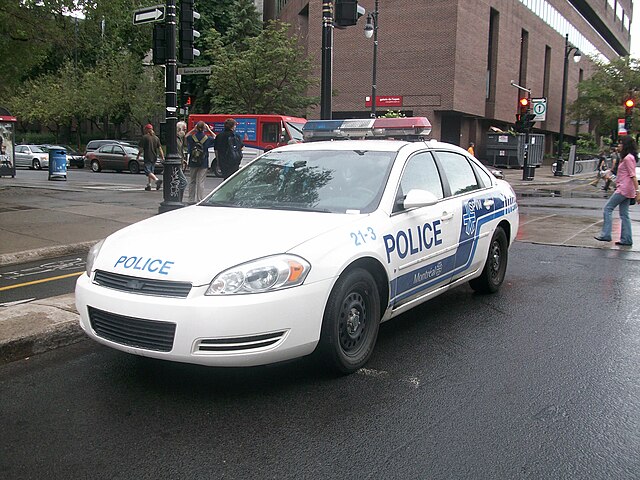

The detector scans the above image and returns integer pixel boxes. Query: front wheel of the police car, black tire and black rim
[318,268,380,374]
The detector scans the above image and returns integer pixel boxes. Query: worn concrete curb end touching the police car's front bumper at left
[0,320,87,365]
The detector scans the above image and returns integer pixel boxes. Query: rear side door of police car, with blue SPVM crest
[435,150,496,281]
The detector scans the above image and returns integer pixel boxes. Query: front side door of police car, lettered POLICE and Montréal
[383,151,461,309]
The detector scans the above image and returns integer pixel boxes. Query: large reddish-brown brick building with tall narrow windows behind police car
[264,0,633,158]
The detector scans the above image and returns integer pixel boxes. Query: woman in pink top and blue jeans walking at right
[594,136,640,246]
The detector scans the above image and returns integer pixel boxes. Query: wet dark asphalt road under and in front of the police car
[0,242,640,480]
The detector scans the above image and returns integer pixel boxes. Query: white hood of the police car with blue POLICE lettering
[94,206,364,285]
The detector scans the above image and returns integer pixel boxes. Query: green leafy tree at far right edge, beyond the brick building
[568,57,640,139]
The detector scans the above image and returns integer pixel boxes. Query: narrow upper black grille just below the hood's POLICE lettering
[93,270,191,298]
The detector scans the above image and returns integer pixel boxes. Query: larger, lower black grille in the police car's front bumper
[88,307,176,352]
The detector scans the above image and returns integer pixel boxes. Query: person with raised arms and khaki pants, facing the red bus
[186,121,216,203]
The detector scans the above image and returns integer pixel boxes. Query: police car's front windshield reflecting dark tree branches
[203,150,396,213]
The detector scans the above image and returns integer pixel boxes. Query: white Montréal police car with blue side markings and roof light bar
[76,118,518,373]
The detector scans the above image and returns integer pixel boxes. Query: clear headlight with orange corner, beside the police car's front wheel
[205,255,311,295]
